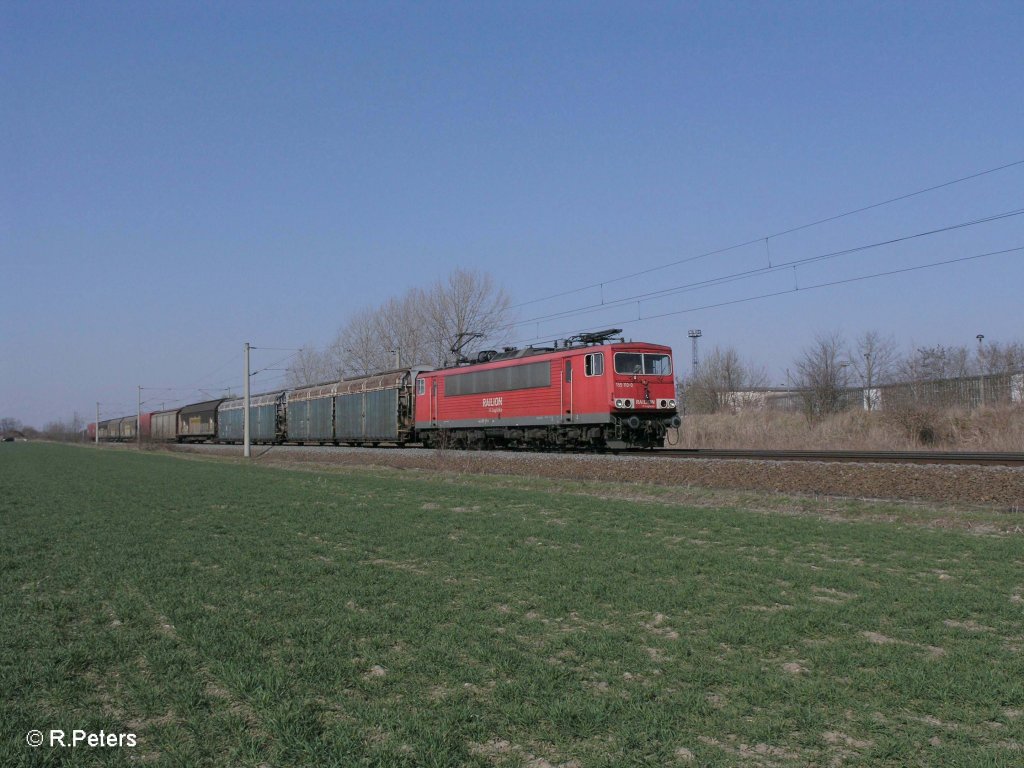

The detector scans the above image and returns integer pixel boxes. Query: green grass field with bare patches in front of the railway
[0,443,1024,768]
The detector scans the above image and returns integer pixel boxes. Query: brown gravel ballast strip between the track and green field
[173,445,1024,511]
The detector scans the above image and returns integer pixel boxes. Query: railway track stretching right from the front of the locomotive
[637,449,1024,467]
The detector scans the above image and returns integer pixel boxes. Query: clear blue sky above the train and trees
[0,2,1024,425]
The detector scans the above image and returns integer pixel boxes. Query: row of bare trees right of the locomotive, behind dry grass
[681,331,1024,414]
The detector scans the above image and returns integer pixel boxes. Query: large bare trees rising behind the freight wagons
[288,269,511,387]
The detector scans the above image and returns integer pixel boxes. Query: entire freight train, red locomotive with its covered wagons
[87,329,680,450]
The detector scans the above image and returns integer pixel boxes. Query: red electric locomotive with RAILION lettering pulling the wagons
[416,329,680,450]
